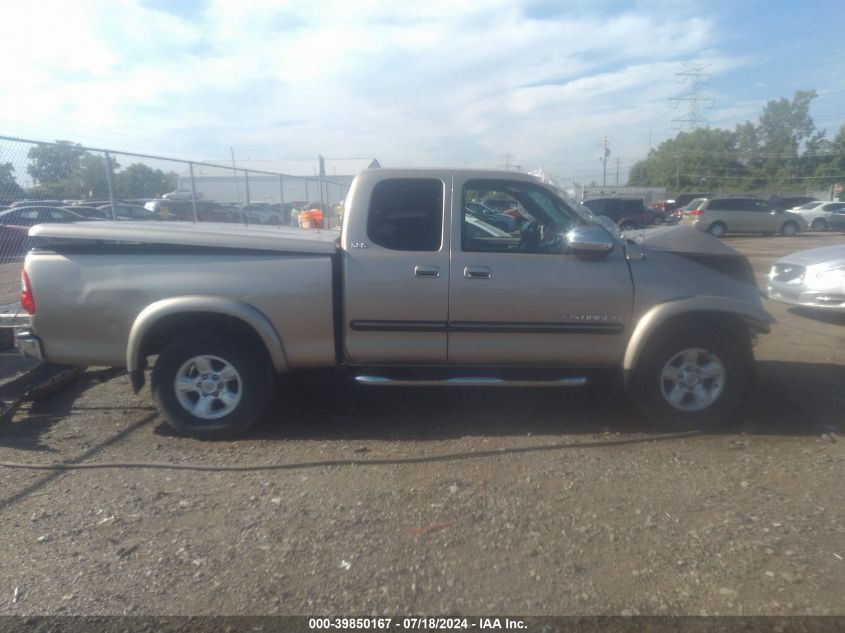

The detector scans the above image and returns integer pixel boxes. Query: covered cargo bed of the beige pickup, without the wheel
[24,222,338,368]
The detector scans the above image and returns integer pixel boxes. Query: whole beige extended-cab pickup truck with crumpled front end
[18,169,772,438]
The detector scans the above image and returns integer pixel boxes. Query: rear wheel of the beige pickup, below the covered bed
[152,332,270,439]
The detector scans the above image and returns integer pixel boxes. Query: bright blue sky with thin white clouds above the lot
[0,0,845,184]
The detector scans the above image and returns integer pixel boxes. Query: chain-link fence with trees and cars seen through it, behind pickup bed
[0,136,351,262]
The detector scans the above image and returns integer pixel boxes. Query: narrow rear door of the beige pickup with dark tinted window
[343,170,451,365]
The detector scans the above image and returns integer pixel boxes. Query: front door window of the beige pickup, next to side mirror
[461,180,584,253]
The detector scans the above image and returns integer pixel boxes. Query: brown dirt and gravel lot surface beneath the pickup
[0,234,845,615]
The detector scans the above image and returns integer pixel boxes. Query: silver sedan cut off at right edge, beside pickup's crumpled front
[768,244,845,313]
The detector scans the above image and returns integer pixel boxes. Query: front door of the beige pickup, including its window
[449,176,633,366]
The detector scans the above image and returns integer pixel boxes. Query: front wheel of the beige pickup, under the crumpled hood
[631,324,751,431]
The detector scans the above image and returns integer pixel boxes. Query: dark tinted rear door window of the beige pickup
[367,178,444,252]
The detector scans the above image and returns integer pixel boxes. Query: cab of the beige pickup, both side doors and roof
[341,170,633,367]
